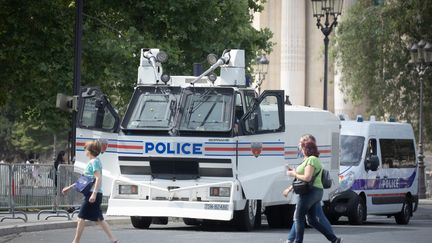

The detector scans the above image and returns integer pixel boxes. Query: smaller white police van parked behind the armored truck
[327,116,418,224]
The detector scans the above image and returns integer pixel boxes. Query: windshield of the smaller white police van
[340,135,365,166]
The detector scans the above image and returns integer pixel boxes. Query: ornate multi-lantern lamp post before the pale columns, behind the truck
[311,0,343,110]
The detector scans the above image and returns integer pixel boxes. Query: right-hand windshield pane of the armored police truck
[179,88,234,132]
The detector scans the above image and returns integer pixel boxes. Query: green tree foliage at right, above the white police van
[335,0,432,143]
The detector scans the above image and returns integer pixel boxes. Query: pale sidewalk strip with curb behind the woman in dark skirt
[0,212,130,236]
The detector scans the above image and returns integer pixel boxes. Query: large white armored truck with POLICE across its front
[75,49,340,230]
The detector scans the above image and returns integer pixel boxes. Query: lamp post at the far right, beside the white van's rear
[409,40,432,199]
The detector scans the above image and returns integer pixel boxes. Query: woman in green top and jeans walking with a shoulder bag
[284,135,342,243]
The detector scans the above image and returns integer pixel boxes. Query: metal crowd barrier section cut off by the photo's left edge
[0,164,28,222]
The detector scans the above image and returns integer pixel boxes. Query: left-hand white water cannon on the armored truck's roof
[137,48,170,85]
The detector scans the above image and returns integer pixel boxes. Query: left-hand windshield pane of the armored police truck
[125,87,180,130]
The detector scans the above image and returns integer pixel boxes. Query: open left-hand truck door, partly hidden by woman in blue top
[74,87,120,195]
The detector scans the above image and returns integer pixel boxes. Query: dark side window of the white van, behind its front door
[379,139,416,168]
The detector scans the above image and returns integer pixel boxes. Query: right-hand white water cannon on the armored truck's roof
[191,49,246,86]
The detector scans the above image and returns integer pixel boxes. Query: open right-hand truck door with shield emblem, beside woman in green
[237,90,285,199]
